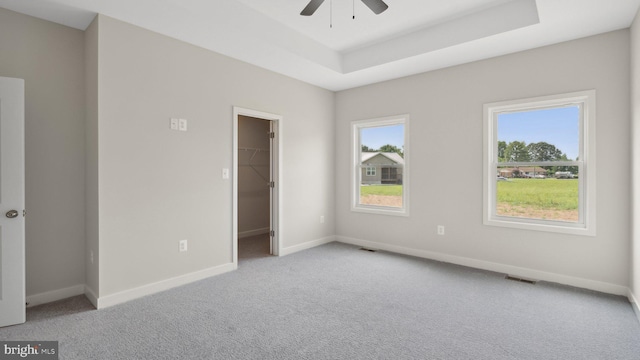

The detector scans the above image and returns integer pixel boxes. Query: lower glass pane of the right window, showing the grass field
[496,166,580,222]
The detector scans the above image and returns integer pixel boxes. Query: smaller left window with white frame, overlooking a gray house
[351,115,409,215]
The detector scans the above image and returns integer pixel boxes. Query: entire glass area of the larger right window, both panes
[496,105,580,222]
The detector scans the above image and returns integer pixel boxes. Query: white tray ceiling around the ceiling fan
[0,0,640,90]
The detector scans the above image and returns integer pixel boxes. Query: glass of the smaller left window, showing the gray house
[359,124,404,208]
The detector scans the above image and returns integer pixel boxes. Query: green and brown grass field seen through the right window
[496,178,579,222]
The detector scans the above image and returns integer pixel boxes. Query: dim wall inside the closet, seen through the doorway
[238,116,271,237]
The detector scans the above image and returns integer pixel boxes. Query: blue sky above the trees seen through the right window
[498,106,580,160]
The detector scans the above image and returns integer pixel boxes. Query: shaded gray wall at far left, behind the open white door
[0,8,85,296]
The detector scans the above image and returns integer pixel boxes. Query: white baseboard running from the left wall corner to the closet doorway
[95,263,235,309]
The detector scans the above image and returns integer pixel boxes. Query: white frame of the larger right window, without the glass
[483,90,596,236]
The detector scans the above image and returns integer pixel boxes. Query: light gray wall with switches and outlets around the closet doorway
[94,16,335,297]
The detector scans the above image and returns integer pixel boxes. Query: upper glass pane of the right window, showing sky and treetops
[497,106,580,162]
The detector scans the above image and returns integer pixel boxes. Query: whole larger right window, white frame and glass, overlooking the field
[484,91,595,235]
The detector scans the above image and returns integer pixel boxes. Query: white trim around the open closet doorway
[231,106,283,268]
